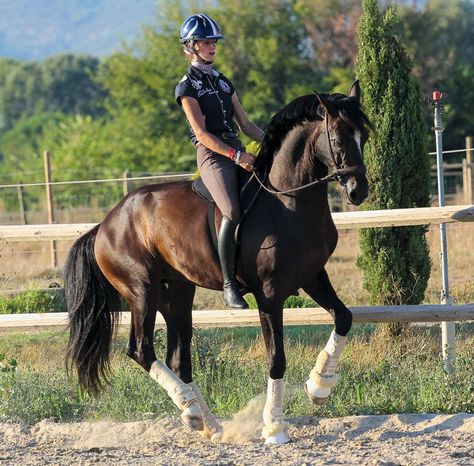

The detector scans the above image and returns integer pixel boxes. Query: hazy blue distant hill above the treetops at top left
[0,0,157,60]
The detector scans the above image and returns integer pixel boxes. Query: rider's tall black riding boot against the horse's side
[217,216,248,309]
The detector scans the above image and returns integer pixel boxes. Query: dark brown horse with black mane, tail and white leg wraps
[64,82,371,444]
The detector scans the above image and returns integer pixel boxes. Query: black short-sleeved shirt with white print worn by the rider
[175,66,236,143]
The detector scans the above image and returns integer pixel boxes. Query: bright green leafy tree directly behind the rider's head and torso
[96,0,321,171]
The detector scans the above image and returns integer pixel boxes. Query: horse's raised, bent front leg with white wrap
[303,269,352,405]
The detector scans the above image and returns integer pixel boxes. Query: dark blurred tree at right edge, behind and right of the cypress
[400,0,474,149]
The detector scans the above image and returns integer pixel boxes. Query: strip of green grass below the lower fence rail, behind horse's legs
[0,324,474,424]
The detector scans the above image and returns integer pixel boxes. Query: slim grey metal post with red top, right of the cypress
[432,91,456,376]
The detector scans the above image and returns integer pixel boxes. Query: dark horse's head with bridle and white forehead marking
[314,81,371,205]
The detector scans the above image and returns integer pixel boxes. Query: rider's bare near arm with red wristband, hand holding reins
[181,96,253,170]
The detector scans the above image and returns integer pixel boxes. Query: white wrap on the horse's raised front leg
[305,330,347,404]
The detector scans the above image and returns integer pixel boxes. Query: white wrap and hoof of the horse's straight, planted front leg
[262,377,291,443]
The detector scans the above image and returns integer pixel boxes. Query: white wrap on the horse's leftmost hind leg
[149,361,204,430]
